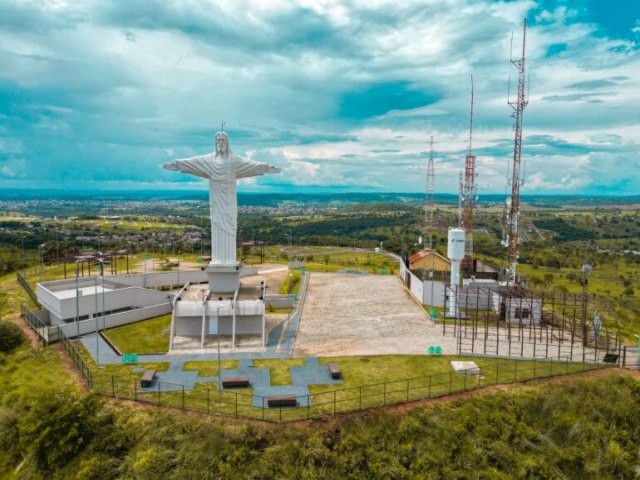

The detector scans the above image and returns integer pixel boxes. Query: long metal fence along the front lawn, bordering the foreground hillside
[88,359,607,423]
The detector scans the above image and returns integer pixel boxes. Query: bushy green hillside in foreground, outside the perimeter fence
[0,342,640,480]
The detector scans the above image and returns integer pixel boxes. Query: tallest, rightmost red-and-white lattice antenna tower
[504,18,529,284]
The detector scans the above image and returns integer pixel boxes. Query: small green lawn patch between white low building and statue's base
[105,314,171,354]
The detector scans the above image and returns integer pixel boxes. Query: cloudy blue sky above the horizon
[0,0,640,195]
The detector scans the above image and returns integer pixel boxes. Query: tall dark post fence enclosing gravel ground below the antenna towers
[441,287,622,362]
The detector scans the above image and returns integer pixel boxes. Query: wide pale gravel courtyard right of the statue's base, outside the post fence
[295,272,456,356]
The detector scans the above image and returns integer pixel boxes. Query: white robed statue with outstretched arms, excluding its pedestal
[163,132,280,265]
